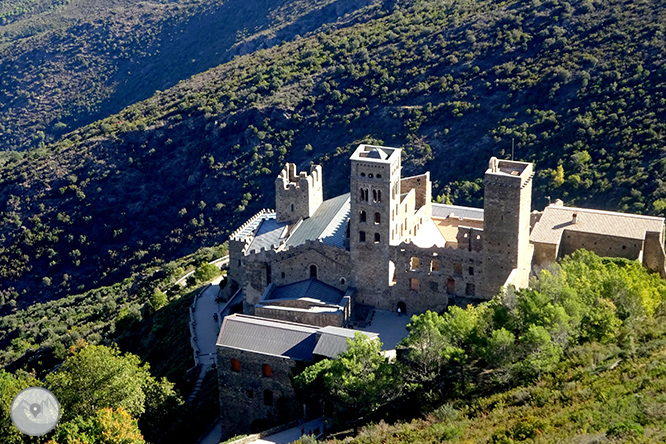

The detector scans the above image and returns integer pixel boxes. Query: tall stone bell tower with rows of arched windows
[349,145,401,300]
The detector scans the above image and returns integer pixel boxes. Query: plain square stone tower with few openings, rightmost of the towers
[481,157,534,299]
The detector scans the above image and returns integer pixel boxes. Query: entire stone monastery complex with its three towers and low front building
[217,145,666,433]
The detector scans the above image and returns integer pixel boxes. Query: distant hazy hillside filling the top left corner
[0,0,373,150]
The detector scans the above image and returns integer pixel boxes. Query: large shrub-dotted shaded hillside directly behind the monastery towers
[0,0,666,308]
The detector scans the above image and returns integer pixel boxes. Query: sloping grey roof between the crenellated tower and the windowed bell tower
[287,193,350,248]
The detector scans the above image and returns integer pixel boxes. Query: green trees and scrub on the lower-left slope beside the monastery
[0,246,226,444]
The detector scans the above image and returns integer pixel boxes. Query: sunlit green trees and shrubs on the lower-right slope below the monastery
[296,250,666,444]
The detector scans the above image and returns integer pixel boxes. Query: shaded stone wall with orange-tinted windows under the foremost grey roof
[217,347,301,439]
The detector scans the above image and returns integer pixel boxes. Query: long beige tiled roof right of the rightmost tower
[530,205,664,244]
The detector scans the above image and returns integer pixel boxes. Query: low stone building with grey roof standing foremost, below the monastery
[217,314,377,437]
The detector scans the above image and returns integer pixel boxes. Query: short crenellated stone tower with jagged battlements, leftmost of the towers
[275,163,324,222]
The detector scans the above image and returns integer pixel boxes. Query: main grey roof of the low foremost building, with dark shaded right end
[217,314,319,361]
